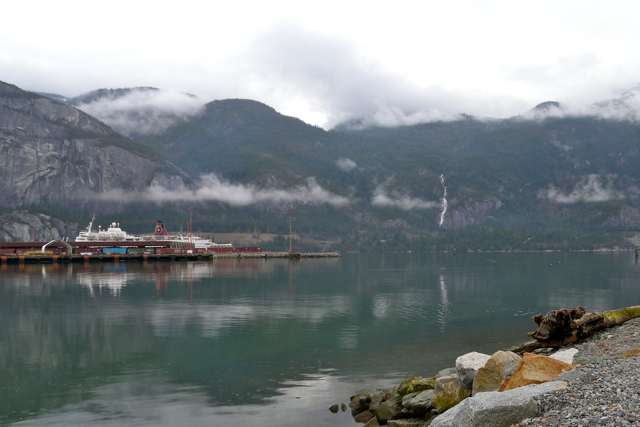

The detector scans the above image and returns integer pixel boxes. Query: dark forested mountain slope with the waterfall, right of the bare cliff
[18,83,640,250]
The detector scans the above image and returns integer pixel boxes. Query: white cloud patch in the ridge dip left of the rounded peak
[70,88,204,137]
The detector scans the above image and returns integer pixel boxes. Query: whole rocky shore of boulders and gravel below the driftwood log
[330,319,640,427]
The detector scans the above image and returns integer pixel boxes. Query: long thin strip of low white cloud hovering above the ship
[95,174,350,207]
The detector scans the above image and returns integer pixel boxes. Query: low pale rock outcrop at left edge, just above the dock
[0,211,79,242]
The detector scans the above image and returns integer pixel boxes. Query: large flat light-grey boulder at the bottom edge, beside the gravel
[431,381,567,427]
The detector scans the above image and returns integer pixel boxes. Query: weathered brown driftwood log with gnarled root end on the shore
[513,305,640,354]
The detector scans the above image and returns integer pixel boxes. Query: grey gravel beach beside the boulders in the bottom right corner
[515,319,640,427]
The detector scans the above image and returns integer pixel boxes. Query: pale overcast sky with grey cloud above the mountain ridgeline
[0,0,640,128]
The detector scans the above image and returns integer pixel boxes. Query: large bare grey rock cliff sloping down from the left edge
[0,82,185,209]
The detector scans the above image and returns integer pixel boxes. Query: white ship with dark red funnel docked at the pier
[76,216,233,248]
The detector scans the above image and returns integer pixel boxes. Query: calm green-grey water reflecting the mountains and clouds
[0,252,640,426]
